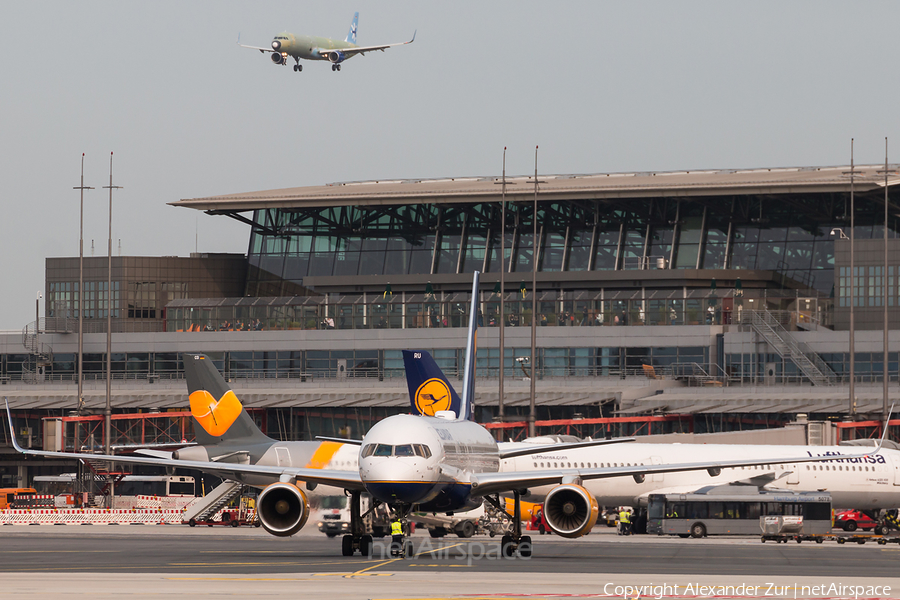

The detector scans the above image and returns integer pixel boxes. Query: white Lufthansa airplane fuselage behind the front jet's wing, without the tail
[500,443,900,509]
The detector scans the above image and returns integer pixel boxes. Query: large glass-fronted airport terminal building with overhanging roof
[0,165,900,488]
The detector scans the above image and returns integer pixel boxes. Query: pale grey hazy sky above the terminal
[0,0,900,330]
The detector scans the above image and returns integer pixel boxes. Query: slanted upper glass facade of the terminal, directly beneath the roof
[247,193,897,296]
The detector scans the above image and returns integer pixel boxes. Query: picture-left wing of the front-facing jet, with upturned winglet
[6,402,365,491]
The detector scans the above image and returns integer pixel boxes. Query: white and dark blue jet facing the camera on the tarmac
[1,272,881,557]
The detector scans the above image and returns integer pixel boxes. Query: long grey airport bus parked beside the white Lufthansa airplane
[647,488,831,538]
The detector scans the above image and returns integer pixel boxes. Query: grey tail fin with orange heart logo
[182,353,270,446]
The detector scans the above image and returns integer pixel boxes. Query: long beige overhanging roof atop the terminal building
[170,165,900,214]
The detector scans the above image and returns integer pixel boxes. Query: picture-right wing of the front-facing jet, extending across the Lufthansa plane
[465,444,881,496]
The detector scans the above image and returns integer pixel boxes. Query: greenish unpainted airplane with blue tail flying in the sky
[238,13,416,72]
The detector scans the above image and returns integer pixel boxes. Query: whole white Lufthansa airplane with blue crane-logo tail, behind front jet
[403,350,900,518]
